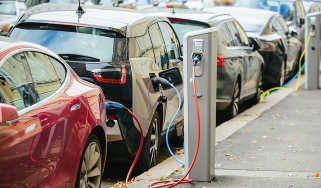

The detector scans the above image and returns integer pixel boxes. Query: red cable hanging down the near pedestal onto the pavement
[149,66,201,188]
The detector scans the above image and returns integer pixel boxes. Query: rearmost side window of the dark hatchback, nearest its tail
[128,32,154,59]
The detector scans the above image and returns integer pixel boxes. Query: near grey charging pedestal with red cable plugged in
[184,28,218,181]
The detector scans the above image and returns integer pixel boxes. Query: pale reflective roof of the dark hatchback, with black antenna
[19,3,168,37]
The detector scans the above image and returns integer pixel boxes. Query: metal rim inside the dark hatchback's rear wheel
[149,118,159,167]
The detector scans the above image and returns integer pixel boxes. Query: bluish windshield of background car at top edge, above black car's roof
[234,0,280,12]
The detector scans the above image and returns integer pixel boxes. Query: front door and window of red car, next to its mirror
[0,53,43,187]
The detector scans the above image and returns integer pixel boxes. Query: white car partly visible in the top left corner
[0,0,27,35]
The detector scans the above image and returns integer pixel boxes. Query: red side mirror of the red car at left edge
[0,103,19,125]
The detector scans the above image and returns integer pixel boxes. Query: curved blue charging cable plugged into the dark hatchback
[152,77,184,166]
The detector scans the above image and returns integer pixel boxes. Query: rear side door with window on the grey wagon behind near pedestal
[224,20,250,99]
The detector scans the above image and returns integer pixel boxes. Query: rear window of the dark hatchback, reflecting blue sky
[10,23,127,62]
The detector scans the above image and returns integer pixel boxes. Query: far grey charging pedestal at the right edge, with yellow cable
[305,12,321,90]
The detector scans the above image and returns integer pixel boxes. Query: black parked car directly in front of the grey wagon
[206,7,302,86]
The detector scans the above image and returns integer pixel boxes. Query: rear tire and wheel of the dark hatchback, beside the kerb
[137,111,161,171]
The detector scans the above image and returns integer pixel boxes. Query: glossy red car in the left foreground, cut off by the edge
[0,38,107,188]
